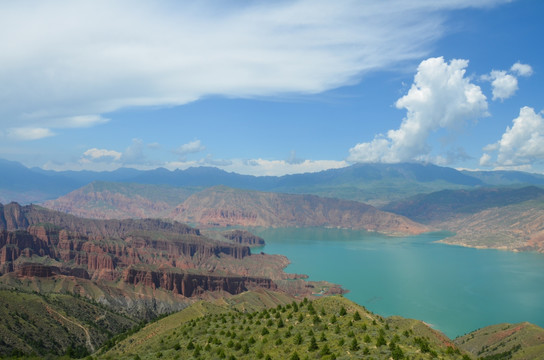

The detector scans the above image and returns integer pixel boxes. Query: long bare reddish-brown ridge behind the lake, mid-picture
[169,186,428,235]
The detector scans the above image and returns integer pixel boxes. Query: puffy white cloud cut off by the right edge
[480,106,544,168]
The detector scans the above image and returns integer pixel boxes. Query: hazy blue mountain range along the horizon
[0,160,544,206]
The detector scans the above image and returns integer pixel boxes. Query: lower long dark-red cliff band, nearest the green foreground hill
[123,268,277,297]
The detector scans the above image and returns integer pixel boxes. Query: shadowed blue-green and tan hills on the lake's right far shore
[385,186,544,252]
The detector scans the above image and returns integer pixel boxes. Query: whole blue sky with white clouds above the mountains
[0,0,544,175]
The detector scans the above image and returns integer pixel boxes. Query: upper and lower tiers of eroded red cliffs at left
[0,203,276,297]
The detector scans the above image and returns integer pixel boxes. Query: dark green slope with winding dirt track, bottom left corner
[0,289,137,357]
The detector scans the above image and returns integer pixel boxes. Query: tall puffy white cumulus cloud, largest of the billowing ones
[348,57,487,163]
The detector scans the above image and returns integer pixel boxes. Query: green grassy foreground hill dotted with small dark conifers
[100,296,468,359]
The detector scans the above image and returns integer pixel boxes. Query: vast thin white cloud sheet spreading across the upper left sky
[0,0,507,137]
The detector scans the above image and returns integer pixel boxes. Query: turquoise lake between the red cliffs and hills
[252,228,544,338]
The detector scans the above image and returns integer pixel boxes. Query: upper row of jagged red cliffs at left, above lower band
[0,225,251,280]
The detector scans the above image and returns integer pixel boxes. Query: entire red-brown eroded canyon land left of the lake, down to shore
[0,203,341,314]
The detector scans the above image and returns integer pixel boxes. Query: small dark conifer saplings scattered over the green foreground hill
[144,299,468,360]
